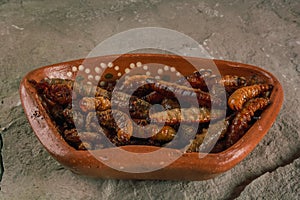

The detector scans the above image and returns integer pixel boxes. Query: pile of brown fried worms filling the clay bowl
[29,72,272,153]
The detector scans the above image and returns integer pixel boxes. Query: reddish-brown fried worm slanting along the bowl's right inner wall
[226,98,270,147]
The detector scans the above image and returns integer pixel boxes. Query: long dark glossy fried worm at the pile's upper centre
[146,78,218,107]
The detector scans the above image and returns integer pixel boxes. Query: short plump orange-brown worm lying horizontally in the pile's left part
[79,96,111,112]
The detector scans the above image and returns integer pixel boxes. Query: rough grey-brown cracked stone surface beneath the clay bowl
[0,0,300,200]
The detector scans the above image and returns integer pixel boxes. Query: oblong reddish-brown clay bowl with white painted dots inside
[20,54,283,180]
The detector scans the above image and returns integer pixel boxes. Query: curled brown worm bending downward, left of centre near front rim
[97,109,133,143]
